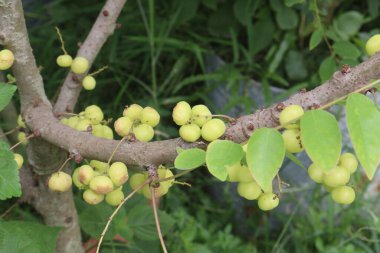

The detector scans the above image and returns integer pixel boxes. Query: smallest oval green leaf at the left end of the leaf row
[174,148,206,170]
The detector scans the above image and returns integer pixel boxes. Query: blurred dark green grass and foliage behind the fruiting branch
[0,0,380,253]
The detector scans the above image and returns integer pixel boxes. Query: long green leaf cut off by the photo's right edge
[346,93,380,180]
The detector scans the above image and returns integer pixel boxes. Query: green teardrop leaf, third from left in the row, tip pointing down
[246,128,285,191]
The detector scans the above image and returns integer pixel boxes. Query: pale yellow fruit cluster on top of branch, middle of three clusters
[114,104,160,142]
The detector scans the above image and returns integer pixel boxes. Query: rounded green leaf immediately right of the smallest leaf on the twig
[206,140,244,181]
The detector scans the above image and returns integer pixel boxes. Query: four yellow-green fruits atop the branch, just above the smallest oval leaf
[172,101,226,142]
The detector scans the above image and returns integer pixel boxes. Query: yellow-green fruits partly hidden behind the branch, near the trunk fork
[61,105,113,140]
